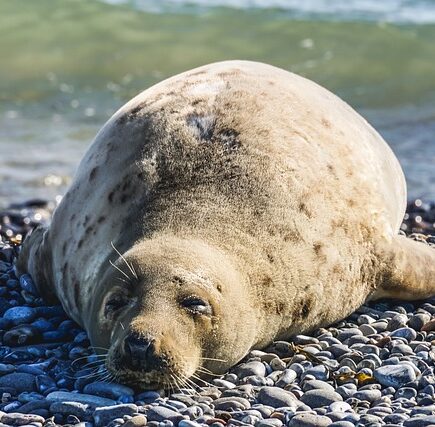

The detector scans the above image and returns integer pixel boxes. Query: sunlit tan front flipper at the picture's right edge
[371,236,435,300]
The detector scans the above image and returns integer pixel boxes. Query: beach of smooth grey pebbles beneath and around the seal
[0,200,435,427]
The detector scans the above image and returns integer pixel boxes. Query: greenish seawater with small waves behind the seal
[0,0,435,207]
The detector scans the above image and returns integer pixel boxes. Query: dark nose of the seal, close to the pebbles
[124,334,156,371]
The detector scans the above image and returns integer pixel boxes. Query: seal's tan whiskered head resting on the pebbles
[87,238,256,389]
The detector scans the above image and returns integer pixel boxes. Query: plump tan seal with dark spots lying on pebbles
[17,61,435,389]
